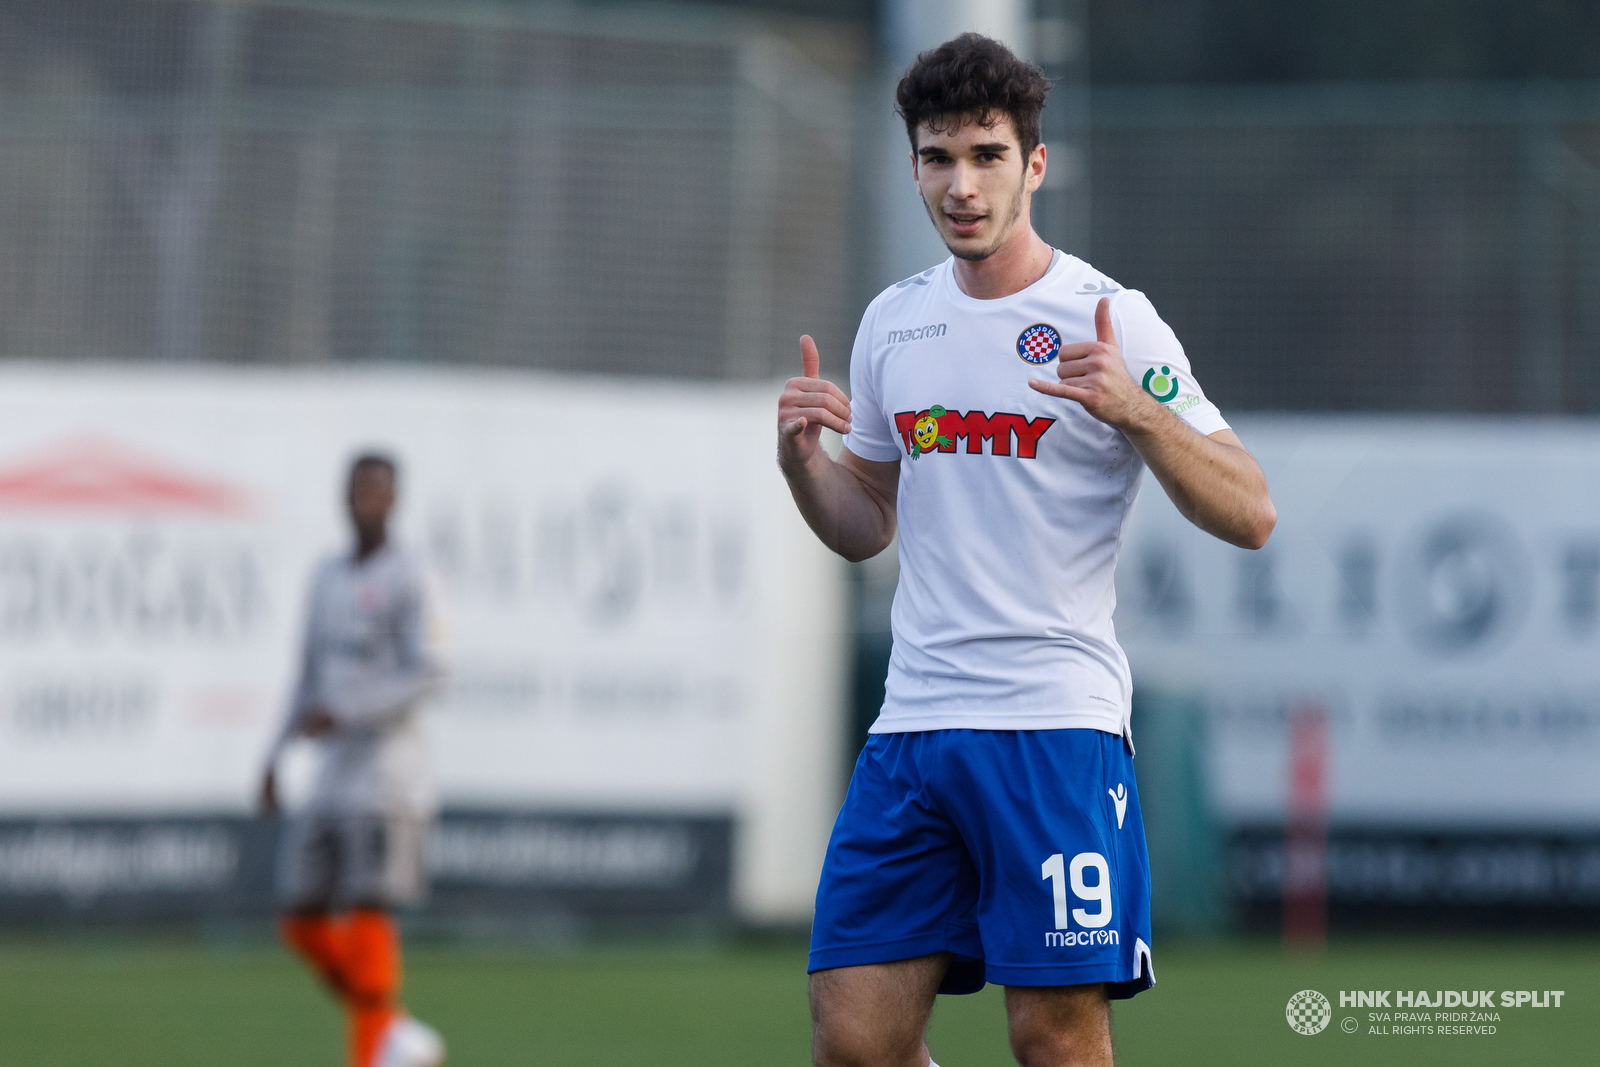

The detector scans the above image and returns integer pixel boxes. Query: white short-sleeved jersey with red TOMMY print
[845,251,1227,734]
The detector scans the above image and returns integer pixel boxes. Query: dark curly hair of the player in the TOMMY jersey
[894,34,1050,158]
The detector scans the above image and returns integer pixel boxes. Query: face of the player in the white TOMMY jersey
[912,118,1045,259]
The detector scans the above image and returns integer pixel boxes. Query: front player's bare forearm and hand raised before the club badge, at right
[1029,298,1278,549]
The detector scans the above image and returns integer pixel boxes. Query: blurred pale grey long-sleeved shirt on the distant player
[274,545,445,817]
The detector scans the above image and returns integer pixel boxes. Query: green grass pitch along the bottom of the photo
[0,939,1600,1067]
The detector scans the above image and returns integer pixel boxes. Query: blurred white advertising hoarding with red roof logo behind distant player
[0,366,846,918]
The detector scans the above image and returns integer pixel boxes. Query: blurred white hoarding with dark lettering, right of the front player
[1117,416,1600,830]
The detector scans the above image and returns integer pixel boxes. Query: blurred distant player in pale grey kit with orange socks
[261,454,445,1067]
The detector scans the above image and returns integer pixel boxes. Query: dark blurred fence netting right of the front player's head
[1091,86,1600,413]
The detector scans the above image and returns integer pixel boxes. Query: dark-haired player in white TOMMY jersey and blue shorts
[778,34,1277,1067]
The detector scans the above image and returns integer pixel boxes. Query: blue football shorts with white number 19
[808,729,1155,998]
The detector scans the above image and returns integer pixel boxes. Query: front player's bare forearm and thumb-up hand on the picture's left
[778,336,899,563]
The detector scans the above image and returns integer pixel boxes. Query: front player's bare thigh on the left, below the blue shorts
[811,952,952,1064]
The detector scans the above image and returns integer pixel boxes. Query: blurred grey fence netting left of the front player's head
[0,0,853,378]
